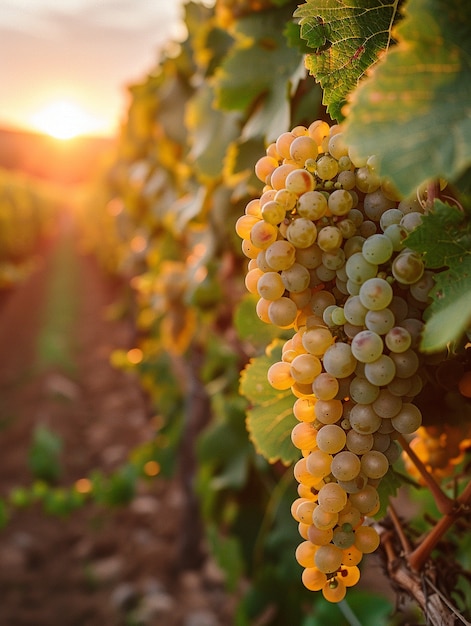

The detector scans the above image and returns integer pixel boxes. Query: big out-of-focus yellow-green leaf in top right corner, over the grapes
[345,0,471,196]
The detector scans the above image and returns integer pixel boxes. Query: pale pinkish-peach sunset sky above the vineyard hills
[0,0,192,138]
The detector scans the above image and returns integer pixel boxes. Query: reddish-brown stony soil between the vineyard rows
[0,232,235,626]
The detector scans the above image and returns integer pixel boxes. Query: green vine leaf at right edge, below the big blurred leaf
[407,200,471,352]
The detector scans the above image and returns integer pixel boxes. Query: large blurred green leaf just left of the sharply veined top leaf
[215,7,301,140]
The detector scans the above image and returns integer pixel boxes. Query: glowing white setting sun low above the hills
[31,100,106,139]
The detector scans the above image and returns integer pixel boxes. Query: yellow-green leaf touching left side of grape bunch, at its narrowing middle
[240,340,299,465]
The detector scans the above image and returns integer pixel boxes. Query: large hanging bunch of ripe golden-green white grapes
[236,120,434,602]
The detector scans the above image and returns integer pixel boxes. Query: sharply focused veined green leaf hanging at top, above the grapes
[294,0,397,121]
